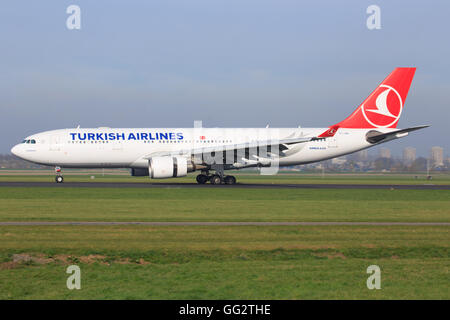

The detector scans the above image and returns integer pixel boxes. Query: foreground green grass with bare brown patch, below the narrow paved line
[0,226,449,299]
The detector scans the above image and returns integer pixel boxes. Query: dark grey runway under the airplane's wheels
[0,181,450,190]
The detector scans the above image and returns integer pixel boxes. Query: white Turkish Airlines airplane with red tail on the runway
[11,68,427,184]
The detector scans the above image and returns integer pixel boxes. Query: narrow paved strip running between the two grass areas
[0,221,450,226]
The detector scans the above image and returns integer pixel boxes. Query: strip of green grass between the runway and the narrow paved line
[0,187,450,222]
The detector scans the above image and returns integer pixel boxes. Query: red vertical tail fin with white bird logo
[336,68,416,129]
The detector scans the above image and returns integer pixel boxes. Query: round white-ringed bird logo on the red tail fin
[361,84,403,128]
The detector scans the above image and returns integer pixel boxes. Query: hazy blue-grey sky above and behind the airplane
[0,0,450,155]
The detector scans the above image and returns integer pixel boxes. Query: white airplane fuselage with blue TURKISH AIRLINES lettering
[11,128,393,168]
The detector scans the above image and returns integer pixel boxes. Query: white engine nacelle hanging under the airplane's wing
[148,157,195,179]
